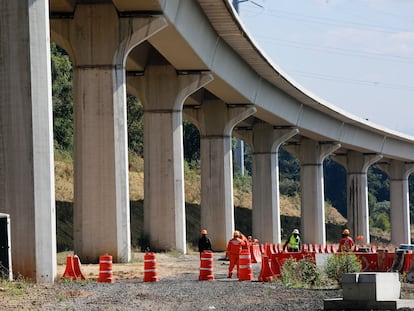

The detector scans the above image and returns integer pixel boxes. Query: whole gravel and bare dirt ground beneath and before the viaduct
[0,253,342,311]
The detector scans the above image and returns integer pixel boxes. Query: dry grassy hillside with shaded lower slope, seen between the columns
[55,155,362,251]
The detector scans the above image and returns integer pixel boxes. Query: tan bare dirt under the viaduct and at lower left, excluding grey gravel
[0,252,236,311]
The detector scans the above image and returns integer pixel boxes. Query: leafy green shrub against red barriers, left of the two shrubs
[282,258,322,288]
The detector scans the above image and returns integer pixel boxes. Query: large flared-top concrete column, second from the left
[52,3,166,262]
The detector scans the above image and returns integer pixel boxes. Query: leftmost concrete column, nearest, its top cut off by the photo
[0,1,56,283]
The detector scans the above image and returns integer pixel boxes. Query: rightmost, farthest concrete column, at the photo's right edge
[378,160,414,245]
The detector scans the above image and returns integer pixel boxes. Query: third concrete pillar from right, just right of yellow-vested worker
[287,138,340,245]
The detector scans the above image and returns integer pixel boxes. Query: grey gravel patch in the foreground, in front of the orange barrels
[41,274,340,310]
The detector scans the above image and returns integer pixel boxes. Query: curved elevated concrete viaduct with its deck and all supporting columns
[0,0,414,283]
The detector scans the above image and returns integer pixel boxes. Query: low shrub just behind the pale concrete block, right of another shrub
[324,253,362,283]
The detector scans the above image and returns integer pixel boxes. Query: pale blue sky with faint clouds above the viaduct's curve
[234,0,414,136]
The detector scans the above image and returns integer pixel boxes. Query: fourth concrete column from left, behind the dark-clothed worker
[186,99,256,251]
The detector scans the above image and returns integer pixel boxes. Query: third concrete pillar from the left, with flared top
[135,55,213,253]
